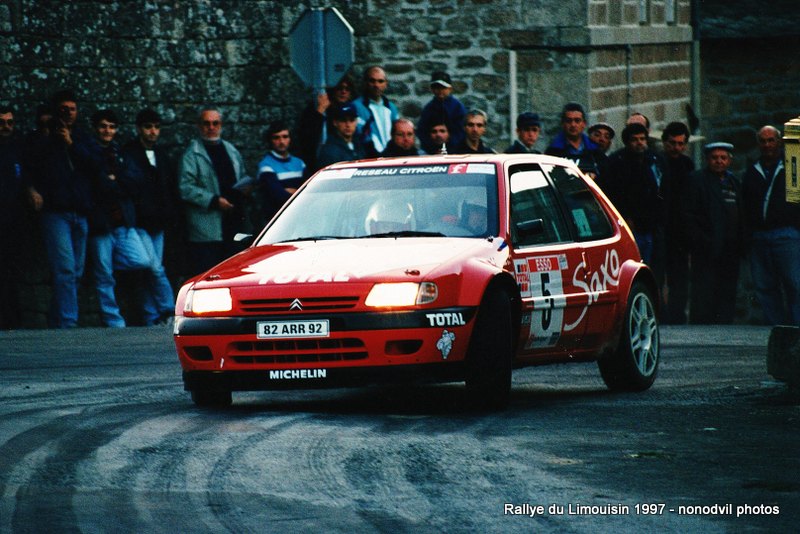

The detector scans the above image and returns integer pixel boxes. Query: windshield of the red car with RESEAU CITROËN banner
[257,163,498,245]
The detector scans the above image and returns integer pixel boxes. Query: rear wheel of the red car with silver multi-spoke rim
[597,282,660,391]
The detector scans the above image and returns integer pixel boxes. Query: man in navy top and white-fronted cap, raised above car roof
[417,71,467,154]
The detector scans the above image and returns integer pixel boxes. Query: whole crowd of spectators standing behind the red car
[0,66,800,329]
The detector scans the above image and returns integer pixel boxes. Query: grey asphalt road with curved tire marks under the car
[0,327,800,534]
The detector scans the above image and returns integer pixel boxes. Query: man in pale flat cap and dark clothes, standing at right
[685,143,743,324]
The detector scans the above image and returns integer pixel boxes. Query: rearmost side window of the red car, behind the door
[547,166,614,241]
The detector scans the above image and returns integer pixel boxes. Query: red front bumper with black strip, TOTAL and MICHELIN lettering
[174,307,477,389]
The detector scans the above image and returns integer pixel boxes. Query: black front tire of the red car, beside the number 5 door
[465,290,513,410]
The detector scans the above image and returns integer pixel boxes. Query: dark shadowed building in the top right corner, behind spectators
[695,0,800,170]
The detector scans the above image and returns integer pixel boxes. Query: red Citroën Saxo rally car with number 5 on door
[174,154,659,408]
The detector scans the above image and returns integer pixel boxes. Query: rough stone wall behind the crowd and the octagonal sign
[0,0,691,168]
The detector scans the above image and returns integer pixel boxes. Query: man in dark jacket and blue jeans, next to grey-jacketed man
[122,109,177,325]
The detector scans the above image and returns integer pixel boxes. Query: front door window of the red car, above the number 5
[510,167,570,247]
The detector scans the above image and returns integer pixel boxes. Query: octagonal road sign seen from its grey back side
[289,7,354,91]
